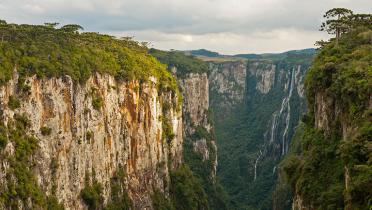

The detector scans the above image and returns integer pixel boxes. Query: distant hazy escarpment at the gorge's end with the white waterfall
[209,53,312,209]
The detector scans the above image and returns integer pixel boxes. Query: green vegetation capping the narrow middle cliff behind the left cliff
[149,49,208,78]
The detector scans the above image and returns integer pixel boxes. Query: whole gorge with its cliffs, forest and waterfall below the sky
[0,10,372,210]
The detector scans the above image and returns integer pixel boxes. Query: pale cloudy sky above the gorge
[0,0,372,54]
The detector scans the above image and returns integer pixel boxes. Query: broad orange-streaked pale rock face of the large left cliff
[0,73,182,209]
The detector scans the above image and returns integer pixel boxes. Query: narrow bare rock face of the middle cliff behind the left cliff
[178,73,217,178]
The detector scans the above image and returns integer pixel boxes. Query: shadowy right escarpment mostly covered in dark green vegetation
[274,23,372,209]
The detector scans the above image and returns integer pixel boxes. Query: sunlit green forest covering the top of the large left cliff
[0,21,178,97]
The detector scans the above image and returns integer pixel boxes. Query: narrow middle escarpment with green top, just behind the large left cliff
[150,49,228,209]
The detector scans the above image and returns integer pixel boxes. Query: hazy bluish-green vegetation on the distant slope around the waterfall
[210,59,314,210]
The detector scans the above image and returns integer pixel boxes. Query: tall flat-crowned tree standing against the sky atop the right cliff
[320,8,353,44]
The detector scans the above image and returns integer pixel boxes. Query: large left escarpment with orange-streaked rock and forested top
[0,21,189,209]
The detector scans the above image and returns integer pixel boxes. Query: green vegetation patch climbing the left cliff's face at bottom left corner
[0,115,63,209]
